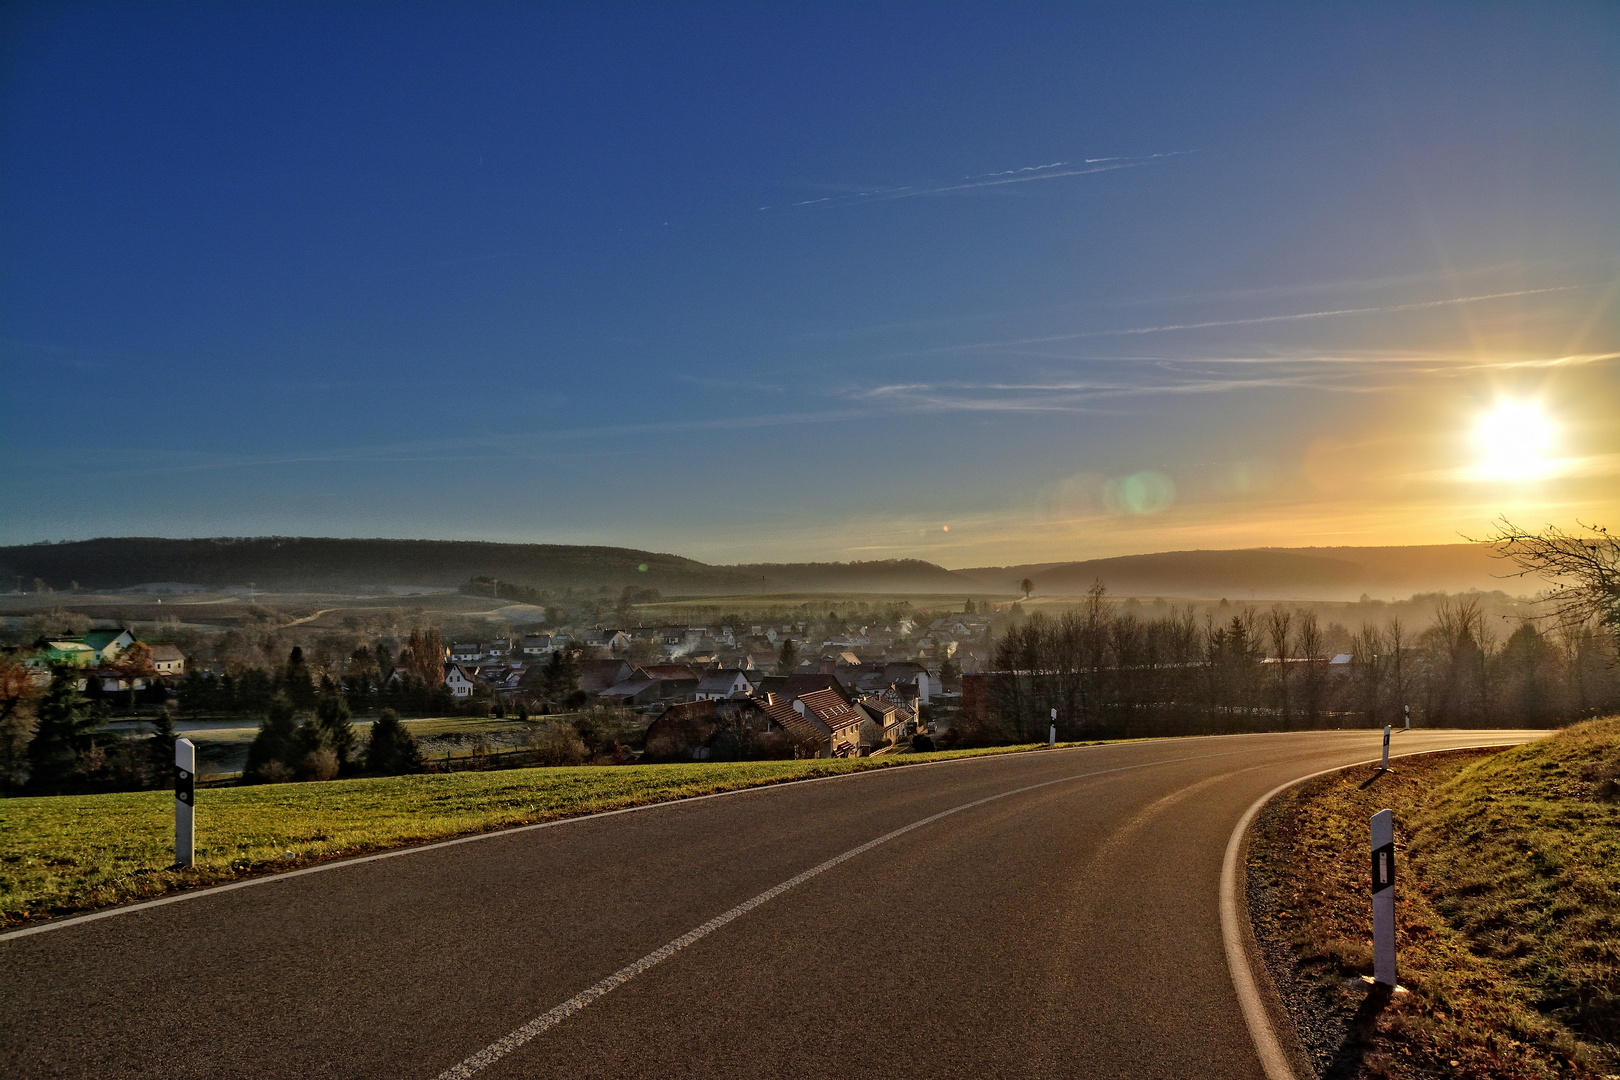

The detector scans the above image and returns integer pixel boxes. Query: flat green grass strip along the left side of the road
[0,743,1077,926]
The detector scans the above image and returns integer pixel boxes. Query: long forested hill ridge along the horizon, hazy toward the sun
[0,536,1516,599]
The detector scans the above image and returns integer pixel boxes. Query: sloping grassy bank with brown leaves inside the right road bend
[1251,719,1620,1080]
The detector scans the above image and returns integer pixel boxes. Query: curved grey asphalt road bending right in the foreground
[0,732,1541,1080]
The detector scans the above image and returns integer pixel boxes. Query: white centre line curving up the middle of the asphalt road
[437,755,1179,1080]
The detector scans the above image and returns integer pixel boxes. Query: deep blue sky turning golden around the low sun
[0,3,1620,565]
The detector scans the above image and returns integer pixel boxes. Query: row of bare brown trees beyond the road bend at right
[957,586,1620,742]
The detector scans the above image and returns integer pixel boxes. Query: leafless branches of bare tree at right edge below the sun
[1482,518,1620,644]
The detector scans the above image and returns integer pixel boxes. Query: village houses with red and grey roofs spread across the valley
[6,604,990,761]
